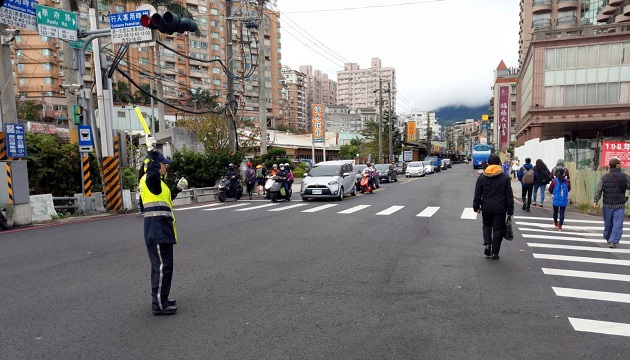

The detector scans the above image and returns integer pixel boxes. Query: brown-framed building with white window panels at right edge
[515,0,630,145]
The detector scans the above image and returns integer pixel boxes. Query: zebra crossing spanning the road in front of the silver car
[173,201,486,220]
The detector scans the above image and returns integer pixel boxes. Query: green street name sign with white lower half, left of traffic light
[37,5,78,41]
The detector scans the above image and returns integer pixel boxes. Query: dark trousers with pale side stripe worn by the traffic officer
[147,244,173,310]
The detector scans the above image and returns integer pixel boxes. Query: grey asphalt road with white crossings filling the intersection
[0,164,630,360]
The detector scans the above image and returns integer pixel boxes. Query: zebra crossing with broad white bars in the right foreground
[514,216,630,337]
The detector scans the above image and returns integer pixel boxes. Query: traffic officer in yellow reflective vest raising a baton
[138,137,188,315]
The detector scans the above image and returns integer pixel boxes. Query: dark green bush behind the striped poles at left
[26,133,102,196]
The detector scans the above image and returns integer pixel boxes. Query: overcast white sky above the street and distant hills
[271,0,519,112]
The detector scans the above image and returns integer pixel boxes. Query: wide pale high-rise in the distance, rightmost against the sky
[337,58,396,114]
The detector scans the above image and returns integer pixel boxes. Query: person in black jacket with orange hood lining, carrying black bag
[473,155,514,260]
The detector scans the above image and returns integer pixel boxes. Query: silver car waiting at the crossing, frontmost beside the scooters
[300,160,357,201]
